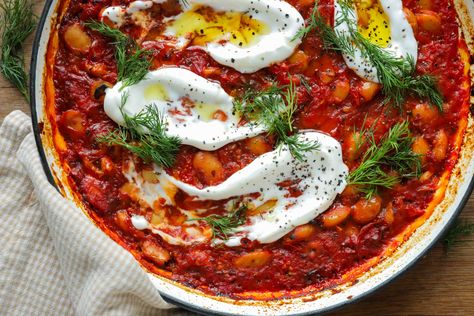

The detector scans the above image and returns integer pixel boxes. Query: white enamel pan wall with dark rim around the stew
[30,0,474,315]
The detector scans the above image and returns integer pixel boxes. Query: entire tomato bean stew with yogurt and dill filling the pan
[44,0,471,300]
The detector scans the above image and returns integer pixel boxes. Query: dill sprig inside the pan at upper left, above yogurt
[86,21,151,88]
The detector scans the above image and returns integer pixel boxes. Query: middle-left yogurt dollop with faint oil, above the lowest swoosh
[104,67,264,150]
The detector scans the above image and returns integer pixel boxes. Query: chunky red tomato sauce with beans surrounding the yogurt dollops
[49,0,469,297]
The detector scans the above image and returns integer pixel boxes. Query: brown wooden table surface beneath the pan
[0,1,474,316]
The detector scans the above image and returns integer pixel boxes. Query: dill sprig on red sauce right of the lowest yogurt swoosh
[347,121,421,198]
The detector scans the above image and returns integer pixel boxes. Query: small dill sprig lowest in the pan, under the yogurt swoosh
[189,205,247,240]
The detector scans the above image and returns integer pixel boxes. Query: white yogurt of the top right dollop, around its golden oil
[334,0,418,83]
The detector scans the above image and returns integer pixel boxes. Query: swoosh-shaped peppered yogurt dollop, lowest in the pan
[163,131,348,246]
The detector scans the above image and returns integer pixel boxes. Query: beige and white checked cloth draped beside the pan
[0,111,193,316]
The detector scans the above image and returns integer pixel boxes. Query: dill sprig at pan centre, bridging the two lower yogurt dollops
[234,81,319,161]
